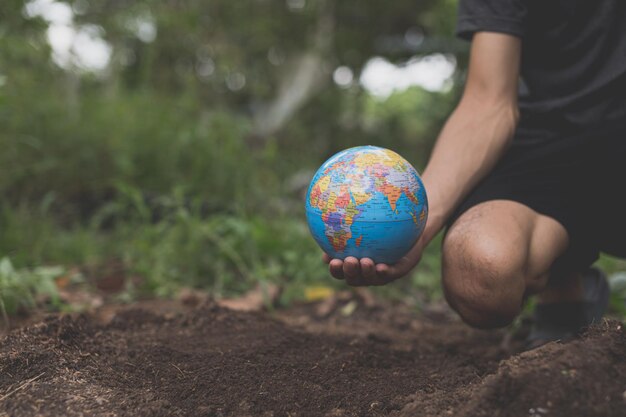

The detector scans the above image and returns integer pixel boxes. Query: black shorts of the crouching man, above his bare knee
[448,115,626,273]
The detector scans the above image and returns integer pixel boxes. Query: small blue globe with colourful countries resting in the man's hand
[305,146,428,264]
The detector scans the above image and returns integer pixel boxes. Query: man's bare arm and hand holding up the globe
[325,32,521,285]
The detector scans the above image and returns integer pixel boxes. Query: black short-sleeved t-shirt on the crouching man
[457,0,626,130]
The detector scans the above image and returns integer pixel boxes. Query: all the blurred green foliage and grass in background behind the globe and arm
[0,0,466,312]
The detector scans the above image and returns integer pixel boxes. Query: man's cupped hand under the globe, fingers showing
[324,235,424,287]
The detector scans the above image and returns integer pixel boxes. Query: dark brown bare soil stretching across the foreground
[0,299,626,417]
